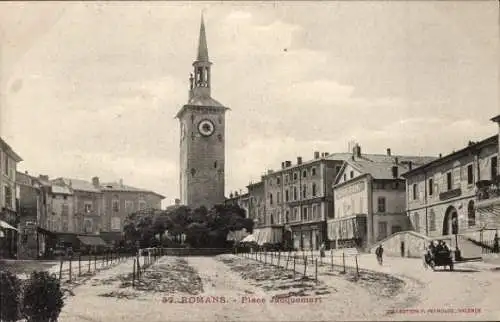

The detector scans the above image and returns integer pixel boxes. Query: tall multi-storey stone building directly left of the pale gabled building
[262,152,347,249]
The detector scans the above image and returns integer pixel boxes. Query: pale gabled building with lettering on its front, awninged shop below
[327,144,435,248]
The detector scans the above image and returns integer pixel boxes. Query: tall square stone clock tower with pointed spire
[176,17,228,209]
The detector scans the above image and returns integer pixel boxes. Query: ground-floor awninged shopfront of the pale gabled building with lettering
[328,214,368,248]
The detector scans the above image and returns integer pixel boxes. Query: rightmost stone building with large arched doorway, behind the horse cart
[403,135,499,241]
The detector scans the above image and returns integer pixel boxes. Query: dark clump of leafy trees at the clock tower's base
[124,205,253,248]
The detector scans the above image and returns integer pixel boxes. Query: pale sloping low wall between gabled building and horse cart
[370,231,431,258]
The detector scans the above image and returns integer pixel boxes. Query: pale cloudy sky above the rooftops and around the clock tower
[0,1,500,204]
